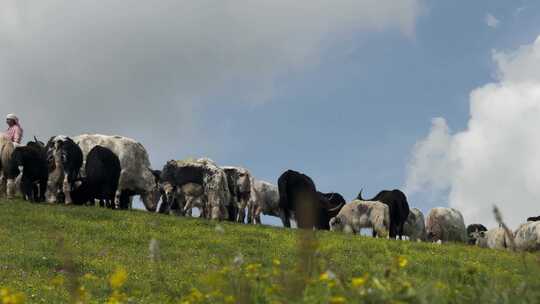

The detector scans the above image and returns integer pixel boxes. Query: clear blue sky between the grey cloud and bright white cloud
[182,1,540,218]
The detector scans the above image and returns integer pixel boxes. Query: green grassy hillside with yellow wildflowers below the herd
[0,201,540,304]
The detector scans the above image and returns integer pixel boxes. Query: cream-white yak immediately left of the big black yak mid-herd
[248,180,285,225]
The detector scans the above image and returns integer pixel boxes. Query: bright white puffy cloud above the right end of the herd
[407,37,540,227]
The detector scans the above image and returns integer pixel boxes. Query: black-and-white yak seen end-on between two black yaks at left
[46,135,83,204]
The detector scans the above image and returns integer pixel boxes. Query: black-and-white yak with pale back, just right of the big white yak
[160,158,230,220]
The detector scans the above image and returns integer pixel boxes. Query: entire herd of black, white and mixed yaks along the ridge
[0,134,540,250]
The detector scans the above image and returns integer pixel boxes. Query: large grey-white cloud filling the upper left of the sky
[0,0,421,166]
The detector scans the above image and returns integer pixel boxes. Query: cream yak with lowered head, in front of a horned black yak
[330,200,390,238]
